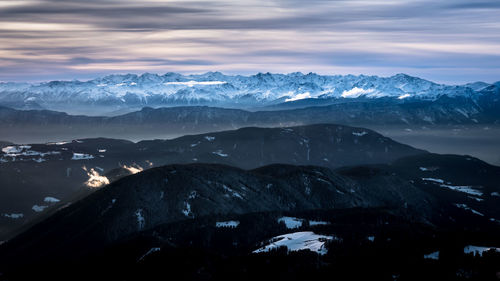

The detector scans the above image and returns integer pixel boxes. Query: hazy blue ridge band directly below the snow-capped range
[0,96,500,142]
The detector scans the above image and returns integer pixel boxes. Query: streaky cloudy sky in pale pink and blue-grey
[0,0,500,84]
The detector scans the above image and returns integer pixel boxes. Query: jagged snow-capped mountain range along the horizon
[0,72,496,114]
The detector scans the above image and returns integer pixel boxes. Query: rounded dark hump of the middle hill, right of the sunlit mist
[142,124,425,169]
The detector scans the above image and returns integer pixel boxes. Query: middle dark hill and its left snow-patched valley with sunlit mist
[0,124,426,240]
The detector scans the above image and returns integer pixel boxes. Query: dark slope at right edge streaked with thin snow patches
[380,154,500,223]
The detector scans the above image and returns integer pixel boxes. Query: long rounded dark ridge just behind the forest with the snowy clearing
[0,164,434,264]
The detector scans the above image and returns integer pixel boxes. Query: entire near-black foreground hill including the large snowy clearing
[0,161,500,280]
